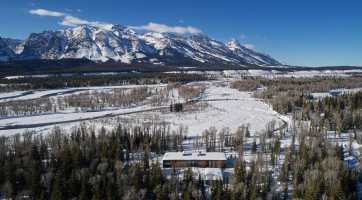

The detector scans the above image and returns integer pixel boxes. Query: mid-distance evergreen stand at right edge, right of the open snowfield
[269,88,362,132]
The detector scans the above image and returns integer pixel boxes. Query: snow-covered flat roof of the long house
[163,152,226,160]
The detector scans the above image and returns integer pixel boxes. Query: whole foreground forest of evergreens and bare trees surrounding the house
[0,119,358,200]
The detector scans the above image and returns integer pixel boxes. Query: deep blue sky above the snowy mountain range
[0,0,362,66]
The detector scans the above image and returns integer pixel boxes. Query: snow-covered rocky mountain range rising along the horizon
[0,25,281,66]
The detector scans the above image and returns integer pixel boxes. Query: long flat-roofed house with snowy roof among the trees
[162,151,226,168]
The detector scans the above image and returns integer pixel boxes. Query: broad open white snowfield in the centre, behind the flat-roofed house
[150,84,283,136]
